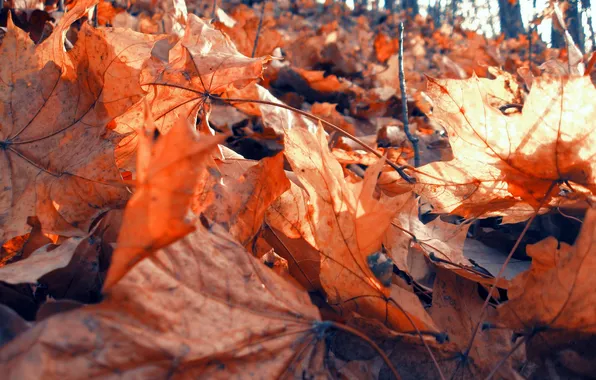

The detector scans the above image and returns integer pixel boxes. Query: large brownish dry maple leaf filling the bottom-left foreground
[0,225,326,379]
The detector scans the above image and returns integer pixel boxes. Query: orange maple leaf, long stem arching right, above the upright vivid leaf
[132,14,270,132]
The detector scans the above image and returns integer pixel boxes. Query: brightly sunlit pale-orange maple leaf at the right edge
[417,76,596,222]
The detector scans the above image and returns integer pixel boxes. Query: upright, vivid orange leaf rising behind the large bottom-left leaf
[105,111,222,289]
